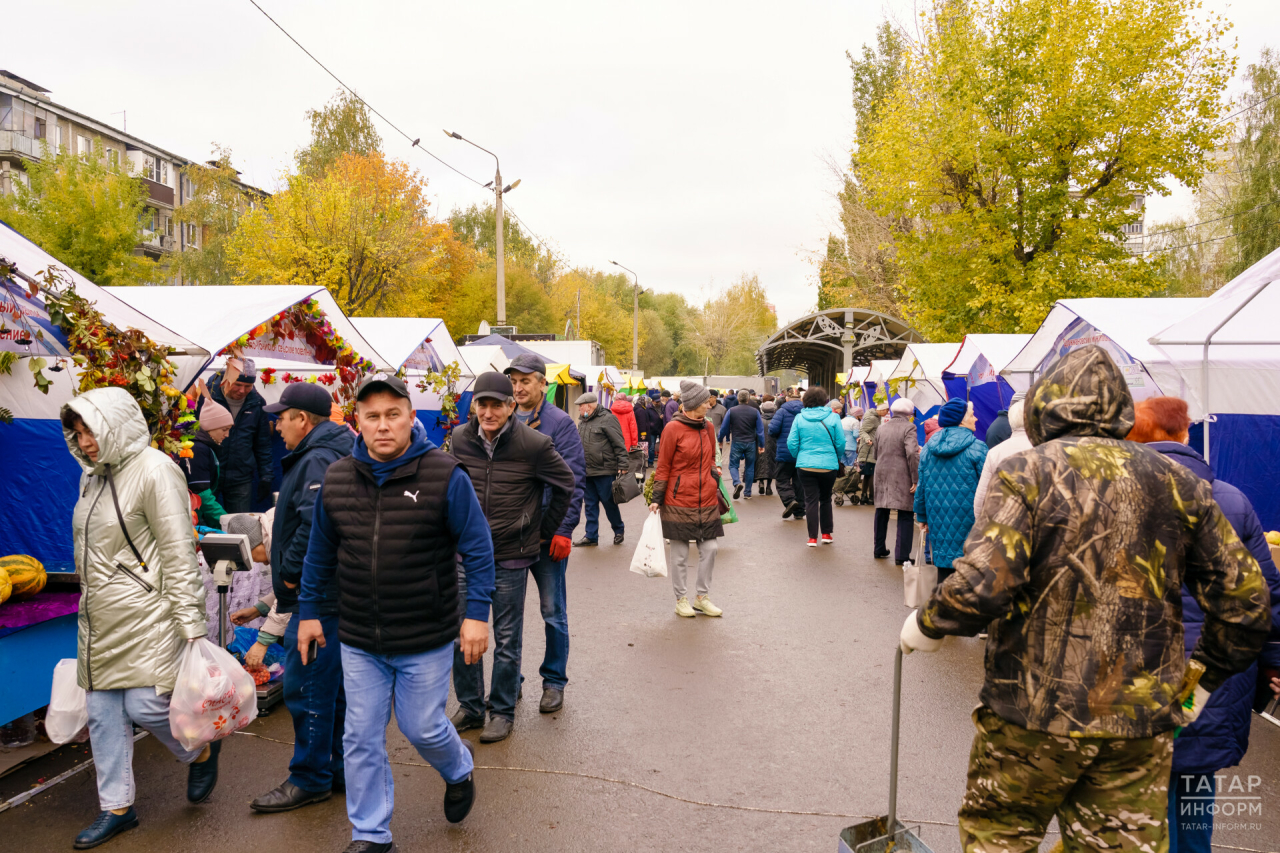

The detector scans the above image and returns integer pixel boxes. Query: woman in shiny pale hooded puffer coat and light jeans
[61,388,220,849]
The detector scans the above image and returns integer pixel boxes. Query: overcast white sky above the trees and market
[0,0,1280,326]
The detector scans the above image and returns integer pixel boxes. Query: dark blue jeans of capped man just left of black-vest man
[284,613,347,793]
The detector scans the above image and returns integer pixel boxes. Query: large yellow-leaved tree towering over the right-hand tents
[856,0,1234,339]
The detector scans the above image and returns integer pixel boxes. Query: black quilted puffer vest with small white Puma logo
[321,448,462,654]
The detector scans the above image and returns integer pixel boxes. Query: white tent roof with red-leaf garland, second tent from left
[105,284,389,379]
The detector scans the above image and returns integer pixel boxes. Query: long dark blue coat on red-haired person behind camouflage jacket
[1149,442,1280,774]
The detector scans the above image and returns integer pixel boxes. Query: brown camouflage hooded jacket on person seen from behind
[918,345,1271,738]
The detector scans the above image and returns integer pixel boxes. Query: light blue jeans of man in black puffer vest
[334,637,475,844]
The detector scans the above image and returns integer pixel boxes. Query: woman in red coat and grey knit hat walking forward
[649,379,724,616]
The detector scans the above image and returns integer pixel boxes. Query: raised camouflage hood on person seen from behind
[1025,345,1133,446]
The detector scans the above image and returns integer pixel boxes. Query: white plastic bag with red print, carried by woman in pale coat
[169,638,257,749]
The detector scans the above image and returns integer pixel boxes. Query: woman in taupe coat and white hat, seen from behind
[872,397,920,566]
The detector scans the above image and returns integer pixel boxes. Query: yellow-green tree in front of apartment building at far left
[0,145,160,286]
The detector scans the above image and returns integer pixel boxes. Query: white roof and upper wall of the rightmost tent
[1149,248,1280,420]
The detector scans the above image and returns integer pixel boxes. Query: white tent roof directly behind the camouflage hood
[1000,298,1207,400]
